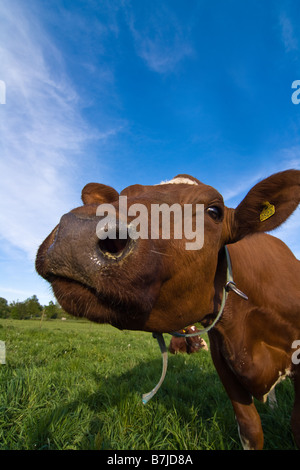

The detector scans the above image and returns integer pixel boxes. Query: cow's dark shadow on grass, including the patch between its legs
[24,353,295,450]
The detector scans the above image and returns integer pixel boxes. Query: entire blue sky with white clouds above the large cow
[0,0,300,304]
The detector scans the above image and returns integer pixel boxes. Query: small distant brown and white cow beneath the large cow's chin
[169,325,208,354]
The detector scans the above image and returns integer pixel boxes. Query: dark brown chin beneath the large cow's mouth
[51,277,152,331]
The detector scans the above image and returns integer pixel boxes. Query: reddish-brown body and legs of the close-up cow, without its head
[209,234,300,448]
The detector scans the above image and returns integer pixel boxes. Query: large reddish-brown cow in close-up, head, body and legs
[36,169,300,449]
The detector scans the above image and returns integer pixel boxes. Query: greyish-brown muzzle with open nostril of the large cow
[36,212,136,287]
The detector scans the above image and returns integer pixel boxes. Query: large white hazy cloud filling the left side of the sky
[0,0,103,259]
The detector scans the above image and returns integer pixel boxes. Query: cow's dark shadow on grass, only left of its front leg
[27,356,235,449]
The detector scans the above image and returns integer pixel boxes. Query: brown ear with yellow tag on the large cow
[227,170,300,243]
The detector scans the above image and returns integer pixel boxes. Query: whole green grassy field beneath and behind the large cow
[0,319,295,450]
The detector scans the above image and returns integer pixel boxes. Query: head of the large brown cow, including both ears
[36,170,300,332]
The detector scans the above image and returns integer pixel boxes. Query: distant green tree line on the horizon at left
[0,295,68,320]
